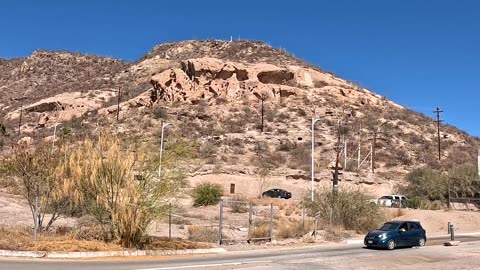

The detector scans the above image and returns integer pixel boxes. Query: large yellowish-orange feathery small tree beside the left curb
[62,132,193,247]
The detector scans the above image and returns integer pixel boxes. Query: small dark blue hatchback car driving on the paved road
[363,221,427,250]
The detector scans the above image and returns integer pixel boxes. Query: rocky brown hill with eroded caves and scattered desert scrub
[0,40,479,194]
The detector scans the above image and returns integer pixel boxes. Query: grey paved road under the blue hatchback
[0,236,480,270]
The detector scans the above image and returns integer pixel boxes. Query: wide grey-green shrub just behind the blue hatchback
[303,188,385,233]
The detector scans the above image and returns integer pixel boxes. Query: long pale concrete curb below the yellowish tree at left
[0,248,227,259]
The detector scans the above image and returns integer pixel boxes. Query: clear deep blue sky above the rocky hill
[0,0,480,136]
